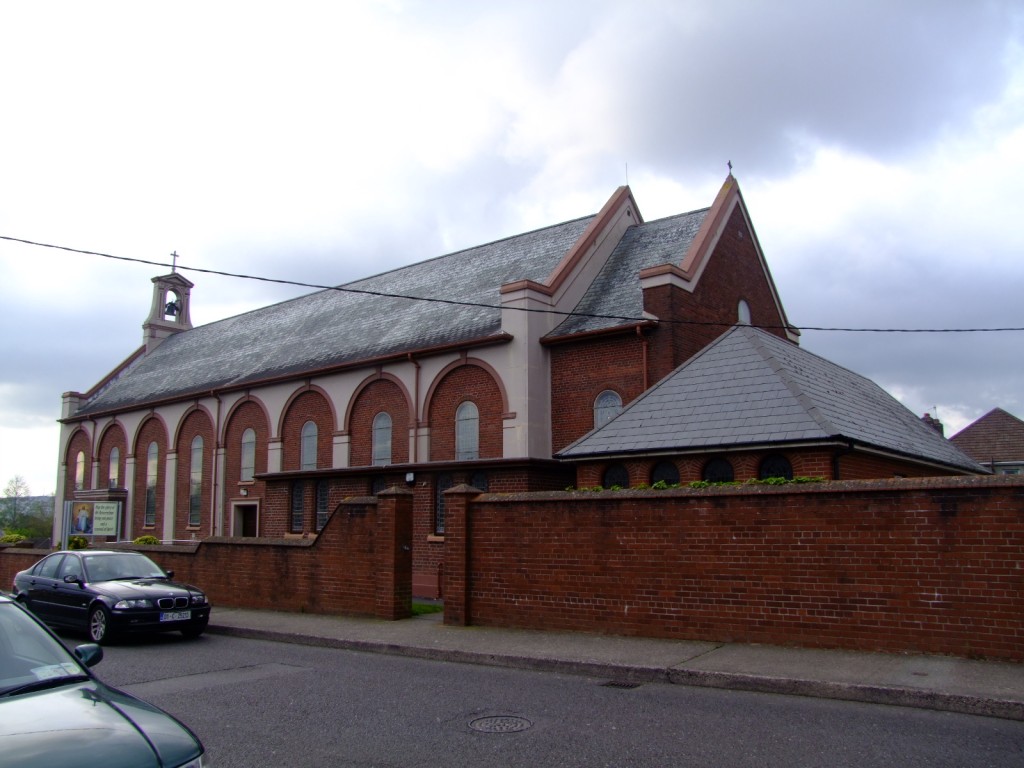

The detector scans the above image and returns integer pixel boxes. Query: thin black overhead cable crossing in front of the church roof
[0,234,1024,334]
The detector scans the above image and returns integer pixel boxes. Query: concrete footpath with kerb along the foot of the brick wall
[208,607,1024,720]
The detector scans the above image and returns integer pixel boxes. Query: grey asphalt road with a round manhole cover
[88,635,1024,768]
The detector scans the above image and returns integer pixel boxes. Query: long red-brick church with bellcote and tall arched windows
[54,175,972,597]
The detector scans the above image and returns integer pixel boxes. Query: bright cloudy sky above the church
[0,0,1024,495]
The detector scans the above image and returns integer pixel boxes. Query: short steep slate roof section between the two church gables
[549,208,710,337]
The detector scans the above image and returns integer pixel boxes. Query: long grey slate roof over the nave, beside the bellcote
[77,216,594,416]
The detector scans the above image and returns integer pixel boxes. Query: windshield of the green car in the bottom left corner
[0,602,87,696]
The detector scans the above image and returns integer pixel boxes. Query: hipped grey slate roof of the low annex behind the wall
[558,326,985,472]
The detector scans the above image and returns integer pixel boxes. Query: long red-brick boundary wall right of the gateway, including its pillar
[444,476,1024,660]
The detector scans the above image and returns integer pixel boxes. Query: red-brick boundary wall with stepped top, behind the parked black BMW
[0,488,413,620]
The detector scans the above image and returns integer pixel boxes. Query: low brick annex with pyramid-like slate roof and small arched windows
[558,325,985,487]
